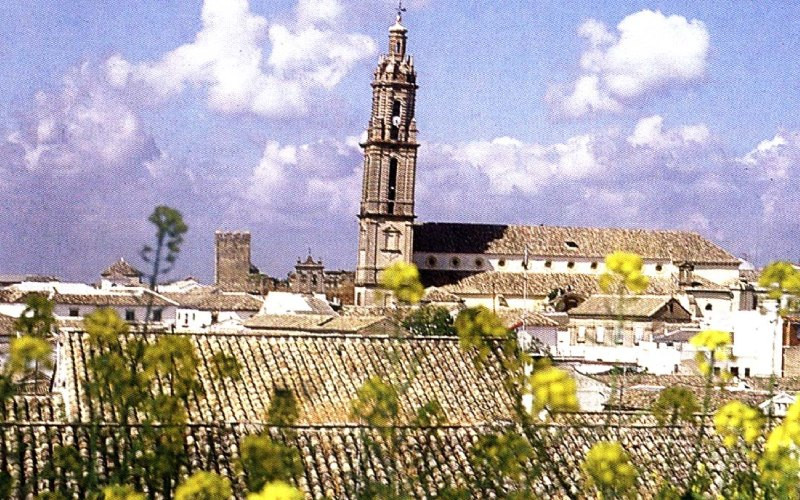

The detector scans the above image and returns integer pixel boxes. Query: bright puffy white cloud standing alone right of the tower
[548,10,709,116]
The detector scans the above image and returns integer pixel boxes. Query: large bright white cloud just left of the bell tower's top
[106,0,376,116]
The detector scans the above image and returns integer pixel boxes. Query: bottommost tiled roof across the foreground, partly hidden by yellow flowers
[0,422,744,499]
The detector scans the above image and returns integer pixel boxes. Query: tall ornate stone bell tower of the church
[355,8,419,305]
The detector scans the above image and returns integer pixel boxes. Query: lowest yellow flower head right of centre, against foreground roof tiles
[581,441,638,495]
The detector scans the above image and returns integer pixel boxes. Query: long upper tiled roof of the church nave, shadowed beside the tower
[414,222,739,265]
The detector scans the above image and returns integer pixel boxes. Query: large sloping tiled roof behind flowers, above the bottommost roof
[61,333,511,425]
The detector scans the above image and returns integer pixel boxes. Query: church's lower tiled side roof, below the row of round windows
[443,271,679,297]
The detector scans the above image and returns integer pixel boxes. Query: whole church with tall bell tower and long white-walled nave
[355,15,742,308]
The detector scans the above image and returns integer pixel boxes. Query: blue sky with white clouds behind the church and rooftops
[0,0,800,280]
